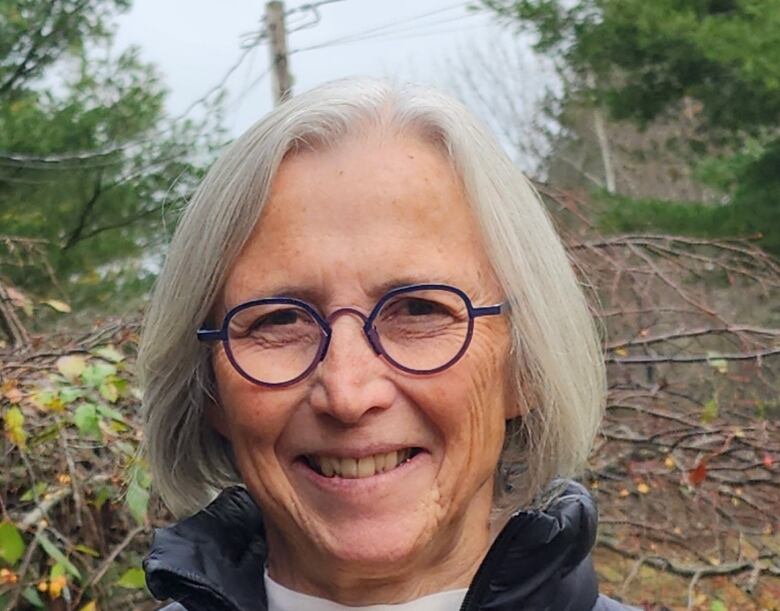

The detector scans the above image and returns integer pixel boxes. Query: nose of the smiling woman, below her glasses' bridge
[311,308,395,424]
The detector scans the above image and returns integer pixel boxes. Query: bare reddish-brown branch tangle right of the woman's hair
[540,185,780,609]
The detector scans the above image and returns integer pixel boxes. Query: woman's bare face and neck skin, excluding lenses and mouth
[210,133,514,605]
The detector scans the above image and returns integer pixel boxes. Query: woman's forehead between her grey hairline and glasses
[226,133,496,306]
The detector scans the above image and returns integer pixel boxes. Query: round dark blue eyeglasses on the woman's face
[197,284,505,386]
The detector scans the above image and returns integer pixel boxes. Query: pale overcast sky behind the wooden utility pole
[111,0,506,134]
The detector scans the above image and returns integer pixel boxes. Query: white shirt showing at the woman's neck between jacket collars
[263,569,467,611]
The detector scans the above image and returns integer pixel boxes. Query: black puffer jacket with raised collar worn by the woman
[144,482,630,611]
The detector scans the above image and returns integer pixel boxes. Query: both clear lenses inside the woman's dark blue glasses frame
[228,289,470,384]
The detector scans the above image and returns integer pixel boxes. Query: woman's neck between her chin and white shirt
[267,484,492,606]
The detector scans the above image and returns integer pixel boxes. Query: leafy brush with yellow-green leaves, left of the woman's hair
[0,329,157,609]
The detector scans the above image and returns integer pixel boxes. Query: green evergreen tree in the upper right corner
[482,0,780,252]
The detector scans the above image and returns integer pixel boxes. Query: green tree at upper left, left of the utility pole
[0,0,223,316]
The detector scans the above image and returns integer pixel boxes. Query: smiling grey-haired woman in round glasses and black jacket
[140,79,636,611]
